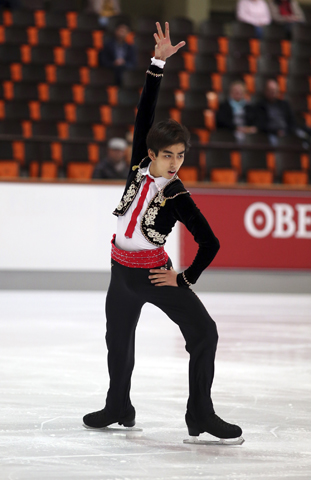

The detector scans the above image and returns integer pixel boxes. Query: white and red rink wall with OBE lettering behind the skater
[0,181,311,293]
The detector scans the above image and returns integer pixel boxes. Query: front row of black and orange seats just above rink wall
[0,142,310,185]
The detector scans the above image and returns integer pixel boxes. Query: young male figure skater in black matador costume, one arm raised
[83,23,242,438]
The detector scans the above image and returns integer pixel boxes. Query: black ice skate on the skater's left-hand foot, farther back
[83,407,142,432]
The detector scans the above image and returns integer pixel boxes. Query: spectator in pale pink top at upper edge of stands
[236,0,271,38]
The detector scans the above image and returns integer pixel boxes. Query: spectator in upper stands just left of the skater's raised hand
[99,23,136,85]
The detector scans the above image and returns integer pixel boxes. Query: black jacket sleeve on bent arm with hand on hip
[174,194,220,287]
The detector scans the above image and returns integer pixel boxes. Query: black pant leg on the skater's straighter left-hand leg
[106,262,143,417]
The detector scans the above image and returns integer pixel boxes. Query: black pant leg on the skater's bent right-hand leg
[148,280,218,422]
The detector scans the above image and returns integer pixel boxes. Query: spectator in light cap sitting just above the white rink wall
[92,138,129,179]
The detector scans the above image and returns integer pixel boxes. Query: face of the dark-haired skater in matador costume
[148,143,185,179]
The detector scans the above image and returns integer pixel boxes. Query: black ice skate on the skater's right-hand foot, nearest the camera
[184,412,244,445]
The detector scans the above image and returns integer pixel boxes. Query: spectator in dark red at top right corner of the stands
[268,0,306,39]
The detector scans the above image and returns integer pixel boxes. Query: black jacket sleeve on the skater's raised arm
[131,65,163,168]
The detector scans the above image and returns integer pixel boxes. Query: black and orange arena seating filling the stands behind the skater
[0,6,311,185]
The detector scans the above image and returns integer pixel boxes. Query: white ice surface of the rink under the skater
[0,292,311,480]
